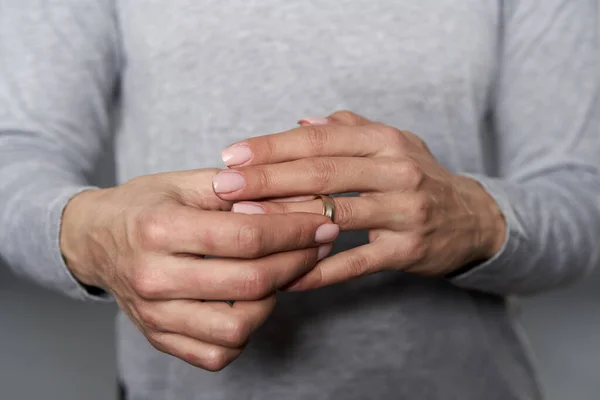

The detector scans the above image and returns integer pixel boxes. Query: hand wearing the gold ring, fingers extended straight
[213,111,506,290]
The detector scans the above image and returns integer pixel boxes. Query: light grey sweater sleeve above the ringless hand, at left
[0,0,119,299]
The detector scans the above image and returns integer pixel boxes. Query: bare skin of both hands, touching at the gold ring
[60,112,506,371]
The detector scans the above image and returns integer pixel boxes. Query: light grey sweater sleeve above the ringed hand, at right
[452,0,600,295]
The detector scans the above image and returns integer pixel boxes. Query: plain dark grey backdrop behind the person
[0,3,600,400]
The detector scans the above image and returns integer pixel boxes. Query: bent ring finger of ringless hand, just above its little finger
[137,295,275,349]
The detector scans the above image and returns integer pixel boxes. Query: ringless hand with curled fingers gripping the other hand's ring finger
[60,169,339,371]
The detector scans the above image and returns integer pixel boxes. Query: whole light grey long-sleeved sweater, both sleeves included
[0,0,600,400]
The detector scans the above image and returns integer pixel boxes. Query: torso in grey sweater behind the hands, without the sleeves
[111,0,537,400]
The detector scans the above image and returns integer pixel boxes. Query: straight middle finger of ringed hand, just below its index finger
[213,157,422,201]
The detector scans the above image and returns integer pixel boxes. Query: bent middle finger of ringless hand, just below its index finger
[137,248,332,301]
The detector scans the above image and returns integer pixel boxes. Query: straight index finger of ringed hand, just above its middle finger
[221,124,391,167]
